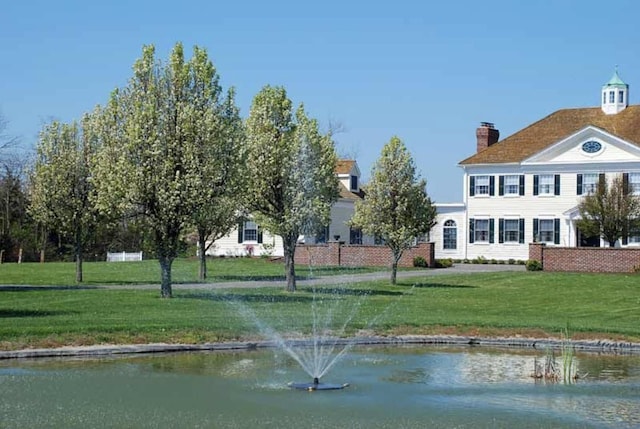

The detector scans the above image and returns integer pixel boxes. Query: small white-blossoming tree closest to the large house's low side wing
[351,137,436,284]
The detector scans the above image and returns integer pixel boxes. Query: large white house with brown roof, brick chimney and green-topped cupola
[431,70,640,260]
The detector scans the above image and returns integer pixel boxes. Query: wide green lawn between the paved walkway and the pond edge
[0,264,640,350]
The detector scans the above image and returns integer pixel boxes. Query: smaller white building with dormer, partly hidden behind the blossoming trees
[207,160,373,256]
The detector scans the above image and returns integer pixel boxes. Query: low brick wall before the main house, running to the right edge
[529,243,640,273]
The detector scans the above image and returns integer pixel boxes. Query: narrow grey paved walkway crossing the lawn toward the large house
[99,264,525,290]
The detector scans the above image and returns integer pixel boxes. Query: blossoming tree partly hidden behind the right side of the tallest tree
[185,47,246,280]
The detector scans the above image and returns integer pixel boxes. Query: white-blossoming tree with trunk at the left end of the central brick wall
[246,86,338,292]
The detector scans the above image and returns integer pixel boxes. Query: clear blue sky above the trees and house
[0,0,640,202]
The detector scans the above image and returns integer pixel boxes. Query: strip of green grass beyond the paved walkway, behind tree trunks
[0,258,379,286]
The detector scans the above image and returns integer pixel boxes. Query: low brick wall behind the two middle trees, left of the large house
[294,242,435,267]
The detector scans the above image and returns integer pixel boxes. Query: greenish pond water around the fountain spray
[0,346,640,428]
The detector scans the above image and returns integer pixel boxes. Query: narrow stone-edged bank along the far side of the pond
[0,335,640,360]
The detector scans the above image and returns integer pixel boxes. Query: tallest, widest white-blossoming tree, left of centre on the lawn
[96,43,242,298]
